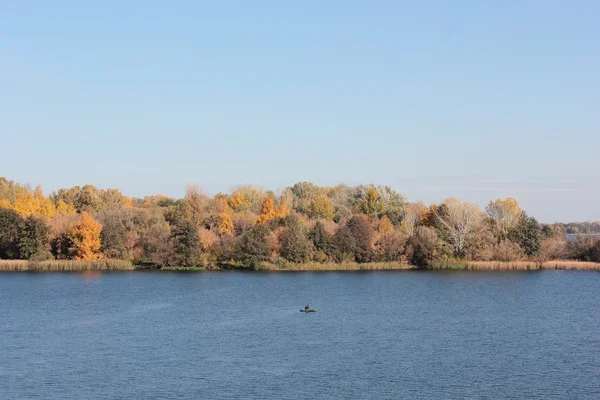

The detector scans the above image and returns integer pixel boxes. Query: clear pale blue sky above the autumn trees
[0,0,600,222]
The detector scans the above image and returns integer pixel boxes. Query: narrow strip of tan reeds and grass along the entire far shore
[0,260,600,272]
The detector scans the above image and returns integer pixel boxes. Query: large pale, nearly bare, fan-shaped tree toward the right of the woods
[435,197,483,257]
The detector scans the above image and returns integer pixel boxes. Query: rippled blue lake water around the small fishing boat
[0,271,600,399]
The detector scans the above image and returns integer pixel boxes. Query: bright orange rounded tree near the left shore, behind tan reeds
[67,212,102,260]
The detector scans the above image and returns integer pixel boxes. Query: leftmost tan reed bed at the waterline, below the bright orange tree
[0,259,135,271]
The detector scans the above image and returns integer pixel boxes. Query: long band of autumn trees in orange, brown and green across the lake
[0,178,600,268]
